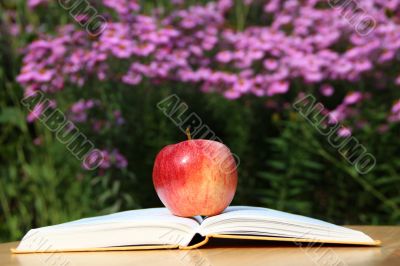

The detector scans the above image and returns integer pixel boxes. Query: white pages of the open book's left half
[17,208,201,251]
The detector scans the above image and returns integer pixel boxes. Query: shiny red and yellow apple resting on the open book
[153,139,238,217]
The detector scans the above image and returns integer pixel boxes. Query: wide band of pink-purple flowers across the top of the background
[18,0,400,135]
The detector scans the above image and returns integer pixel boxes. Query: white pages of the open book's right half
[200,206,373,242]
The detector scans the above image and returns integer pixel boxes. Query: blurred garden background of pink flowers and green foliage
[0,0,400,242]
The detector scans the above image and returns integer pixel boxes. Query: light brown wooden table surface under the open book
[0,226,400,266]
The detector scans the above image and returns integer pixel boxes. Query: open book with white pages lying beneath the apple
[12,206,380,253]
